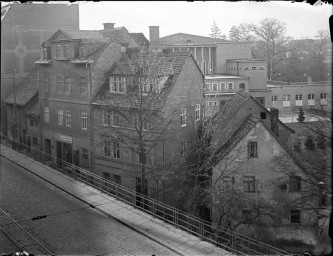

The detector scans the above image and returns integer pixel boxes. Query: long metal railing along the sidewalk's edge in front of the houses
[0,135,289,255]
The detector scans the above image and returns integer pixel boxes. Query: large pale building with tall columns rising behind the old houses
[149,26,271,117]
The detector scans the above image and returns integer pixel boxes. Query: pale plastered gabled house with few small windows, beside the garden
[202,91,326,249]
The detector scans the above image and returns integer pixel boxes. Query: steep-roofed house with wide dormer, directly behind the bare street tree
[93,53,204,205]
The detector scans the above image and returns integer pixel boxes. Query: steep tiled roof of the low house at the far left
[4,67,38,106]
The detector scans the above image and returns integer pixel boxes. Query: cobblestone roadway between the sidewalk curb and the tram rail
[0,157,176,255]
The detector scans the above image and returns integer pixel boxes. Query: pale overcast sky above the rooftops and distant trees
[76,1,333,39]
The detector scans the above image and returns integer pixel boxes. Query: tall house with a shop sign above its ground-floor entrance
[36,23,148,169]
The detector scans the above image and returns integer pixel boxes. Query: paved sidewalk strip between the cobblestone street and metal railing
[0,145,232,256]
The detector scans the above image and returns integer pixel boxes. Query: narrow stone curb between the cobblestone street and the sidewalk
[0,151,184,256]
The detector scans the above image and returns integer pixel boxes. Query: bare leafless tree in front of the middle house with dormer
[94,54,179,195]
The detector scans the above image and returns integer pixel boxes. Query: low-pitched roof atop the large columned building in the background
[158,33,228,46]
